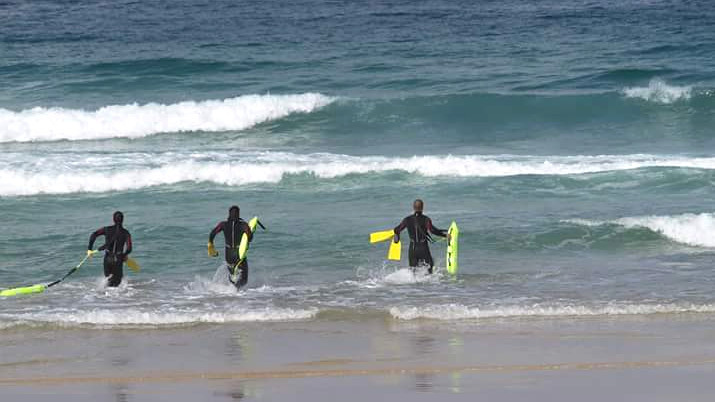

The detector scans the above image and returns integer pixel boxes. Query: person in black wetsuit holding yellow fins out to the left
[393,199,448,274]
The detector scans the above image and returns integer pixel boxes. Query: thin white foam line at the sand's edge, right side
[390,303,715,320]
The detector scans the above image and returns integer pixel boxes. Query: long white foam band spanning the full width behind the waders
[7,152,715,196]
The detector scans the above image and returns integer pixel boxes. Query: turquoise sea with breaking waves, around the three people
[0,1,715,327]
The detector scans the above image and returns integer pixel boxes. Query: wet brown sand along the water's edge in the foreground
[0,314,715,401]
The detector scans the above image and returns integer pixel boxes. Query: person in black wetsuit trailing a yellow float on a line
[87,211,132,287]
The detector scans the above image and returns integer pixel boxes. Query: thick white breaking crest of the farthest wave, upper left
[0,93,335,142]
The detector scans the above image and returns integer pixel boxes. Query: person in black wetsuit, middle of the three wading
[208,205,253,288]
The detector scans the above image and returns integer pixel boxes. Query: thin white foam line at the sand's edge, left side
[0,307,318,327]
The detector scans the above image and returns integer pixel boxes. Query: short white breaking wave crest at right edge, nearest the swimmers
[567,213,715,247]
